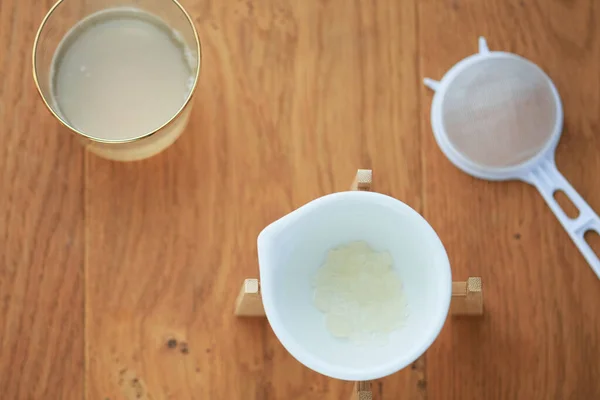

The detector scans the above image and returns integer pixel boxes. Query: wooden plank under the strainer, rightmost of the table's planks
[419,0,600,400]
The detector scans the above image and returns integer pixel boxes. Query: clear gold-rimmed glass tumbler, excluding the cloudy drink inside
[33,0,202,161]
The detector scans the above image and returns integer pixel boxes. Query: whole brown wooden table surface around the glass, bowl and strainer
[0,0,600,400]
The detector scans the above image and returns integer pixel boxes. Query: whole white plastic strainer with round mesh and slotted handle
[424,38,600,277]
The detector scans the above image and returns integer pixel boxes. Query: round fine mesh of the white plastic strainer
[441,58,558,168]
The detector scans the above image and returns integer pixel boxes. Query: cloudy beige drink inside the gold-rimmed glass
[51,8,196,155]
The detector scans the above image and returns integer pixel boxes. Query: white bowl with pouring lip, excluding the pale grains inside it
[258,191,452,381]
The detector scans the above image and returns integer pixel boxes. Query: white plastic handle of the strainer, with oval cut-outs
[527,159,600,278]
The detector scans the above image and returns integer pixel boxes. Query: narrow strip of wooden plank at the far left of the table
[0,0,84,400]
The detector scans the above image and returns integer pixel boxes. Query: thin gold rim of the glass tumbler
[31,0,202,144]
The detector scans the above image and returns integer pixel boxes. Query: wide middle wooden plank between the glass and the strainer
[86,0,424,400]
